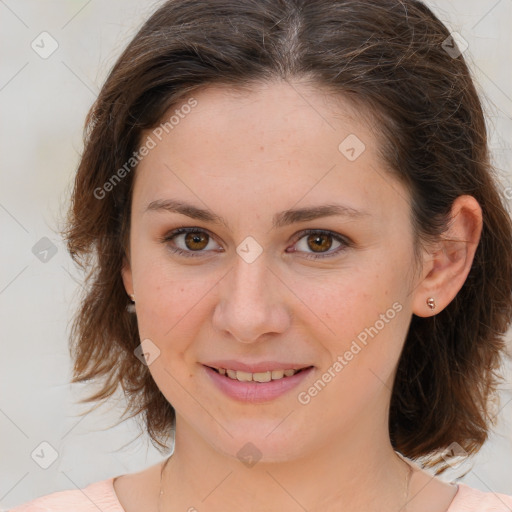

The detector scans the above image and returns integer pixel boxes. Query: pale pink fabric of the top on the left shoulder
[9,478,125,512]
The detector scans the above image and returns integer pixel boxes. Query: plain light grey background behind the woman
[0,0,512,509]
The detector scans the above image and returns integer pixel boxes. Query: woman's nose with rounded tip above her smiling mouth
[213,254,293,343]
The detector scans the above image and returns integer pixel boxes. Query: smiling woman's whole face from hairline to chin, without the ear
[123,82,424,461]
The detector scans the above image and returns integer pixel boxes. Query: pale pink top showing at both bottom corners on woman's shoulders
[9,477,512,512]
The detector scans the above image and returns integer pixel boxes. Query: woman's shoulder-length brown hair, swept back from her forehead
[64,0,512,472]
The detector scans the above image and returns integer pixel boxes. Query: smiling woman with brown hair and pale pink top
[10,0,512,512]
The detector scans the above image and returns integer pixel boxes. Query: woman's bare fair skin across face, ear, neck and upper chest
[115,81,482,512]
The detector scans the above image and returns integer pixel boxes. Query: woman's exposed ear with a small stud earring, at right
[412,195,483,317]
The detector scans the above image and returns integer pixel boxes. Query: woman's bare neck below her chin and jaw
[160,416,410,512]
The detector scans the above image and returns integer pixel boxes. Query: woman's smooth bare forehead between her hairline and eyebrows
[135,82,407,228]
